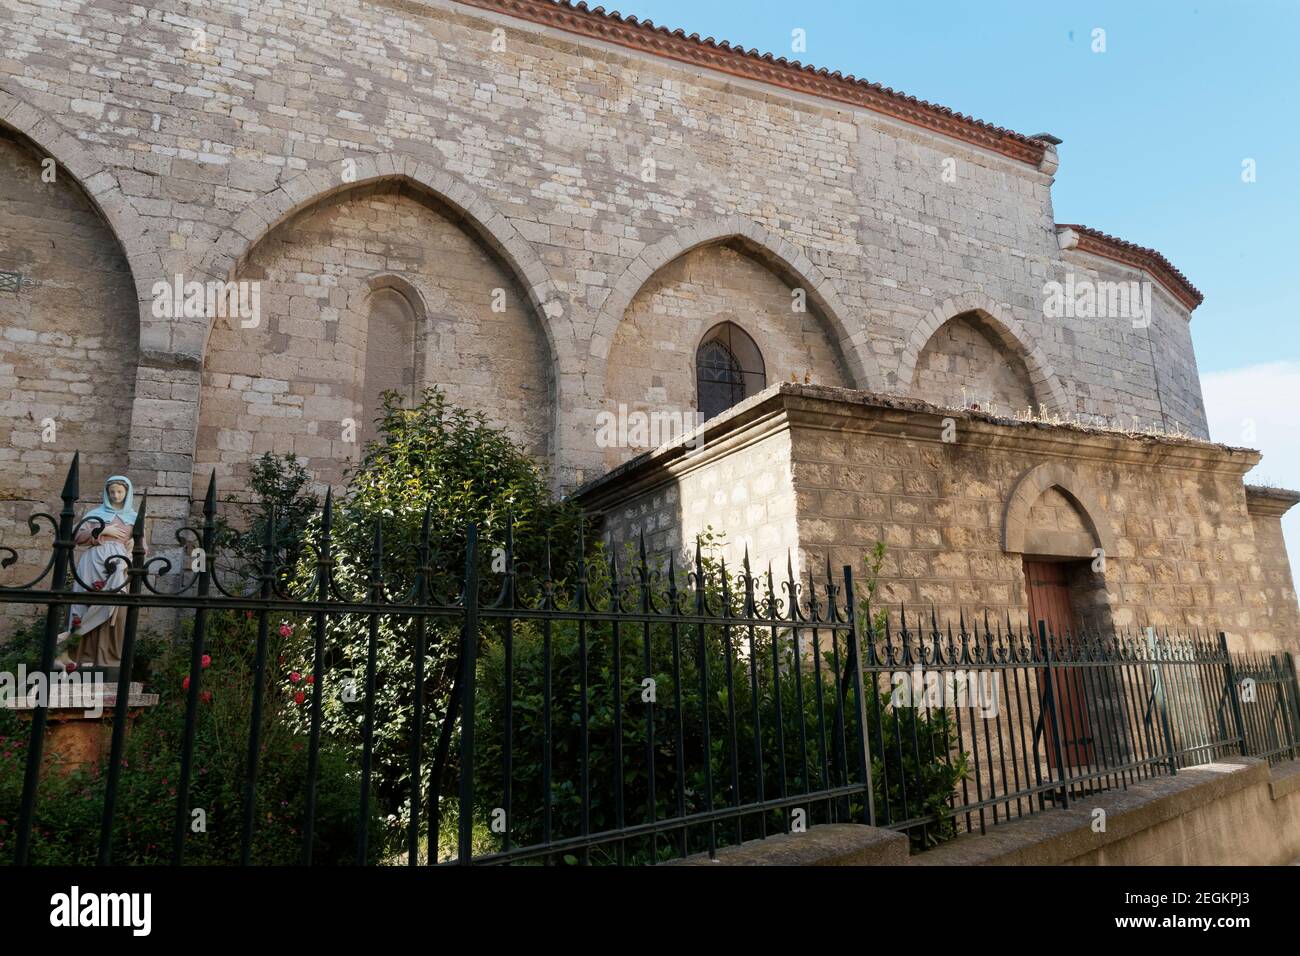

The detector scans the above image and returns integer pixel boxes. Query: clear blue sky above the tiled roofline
[618,0,1300,568]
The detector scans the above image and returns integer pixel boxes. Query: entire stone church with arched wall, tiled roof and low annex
[0,0,1300,650]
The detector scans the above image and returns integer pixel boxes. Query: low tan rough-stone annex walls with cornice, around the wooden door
[581,385,1300,653]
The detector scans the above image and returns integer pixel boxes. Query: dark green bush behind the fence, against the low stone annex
[475,538,967,862]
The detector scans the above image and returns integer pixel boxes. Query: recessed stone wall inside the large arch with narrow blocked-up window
[195,185,553,490]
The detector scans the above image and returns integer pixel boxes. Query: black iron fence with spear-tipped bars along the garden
[0,460,1300,865]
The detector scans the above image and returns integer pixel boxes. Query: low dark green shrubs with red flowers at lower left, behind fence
[0,613,381,865]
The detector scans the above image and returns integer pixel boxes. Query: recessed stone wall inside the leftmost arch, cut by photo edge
[0,129,139,502]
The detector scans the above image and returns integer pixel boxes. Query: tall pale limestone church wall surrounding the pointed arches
[0,0,1204,518]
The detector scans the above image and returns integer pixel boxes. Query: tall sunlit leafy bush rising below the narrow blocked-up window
[290,389,579,847]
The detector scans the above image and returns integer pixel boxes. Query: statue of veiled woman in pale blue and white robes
[55,475,144,669]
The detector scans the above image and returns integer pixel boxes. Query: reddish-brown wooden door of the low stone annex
[1024,559,1093,767]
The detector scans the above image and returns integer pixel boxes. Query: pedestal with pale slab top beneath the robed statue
[0,683,159,777]
